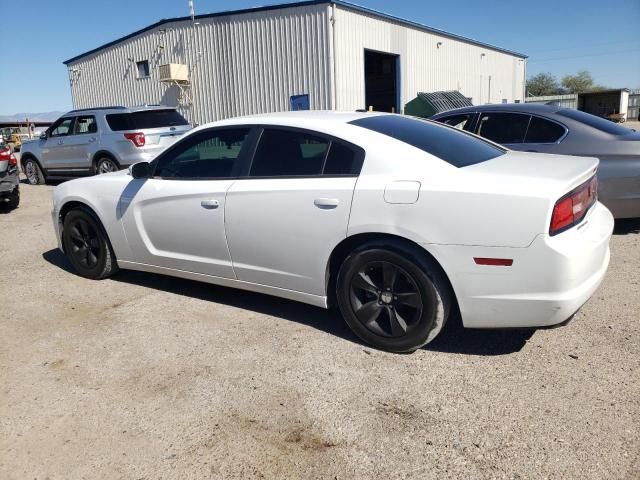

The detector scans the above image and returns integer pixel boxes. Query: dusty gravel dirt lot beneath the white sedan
[0,181,640,480]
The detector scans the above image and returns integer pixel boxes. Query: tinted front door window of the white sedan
[154,128,250,179]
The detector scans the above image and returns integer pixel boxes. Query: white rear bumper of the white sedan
[425,203,613,328]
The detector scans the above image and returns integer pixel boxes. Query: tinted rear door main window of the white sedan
[249,128,330,177]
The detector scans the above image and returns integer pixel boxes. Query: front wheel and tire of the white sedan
[62,208,118,280]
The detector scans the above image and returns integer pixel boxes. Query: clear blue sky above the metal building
[0,0,640,115]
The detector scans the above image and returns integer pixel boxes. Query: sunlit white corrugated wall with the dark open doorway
[335,6,526,110]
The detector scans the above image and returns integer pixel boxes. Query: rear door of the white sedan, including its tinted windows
[225,127,364,296]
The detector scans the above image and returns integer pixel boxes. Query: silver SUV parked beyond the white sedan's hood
[20,106,191,185]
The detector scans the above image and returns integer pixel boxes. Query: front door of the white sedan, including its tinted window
[119,128,249,278]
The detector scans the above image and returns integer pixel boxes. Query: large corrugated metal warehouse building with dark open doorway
[64,0,526,124]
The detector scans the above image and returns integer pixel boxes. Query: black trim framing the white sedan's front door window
[149,125,256,182]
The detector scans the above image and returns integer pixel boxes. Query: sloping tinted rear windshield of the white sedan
[351,115,505,167]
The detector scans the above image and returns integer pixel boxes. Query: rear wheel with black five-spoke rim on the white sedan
[336,243,452,353]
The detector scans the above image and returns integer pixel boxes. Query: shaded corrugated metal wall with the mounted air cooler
[69,5,331,124]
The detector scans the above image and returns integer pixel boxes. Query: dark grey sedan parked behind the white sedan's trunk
[431,103,640,218]
